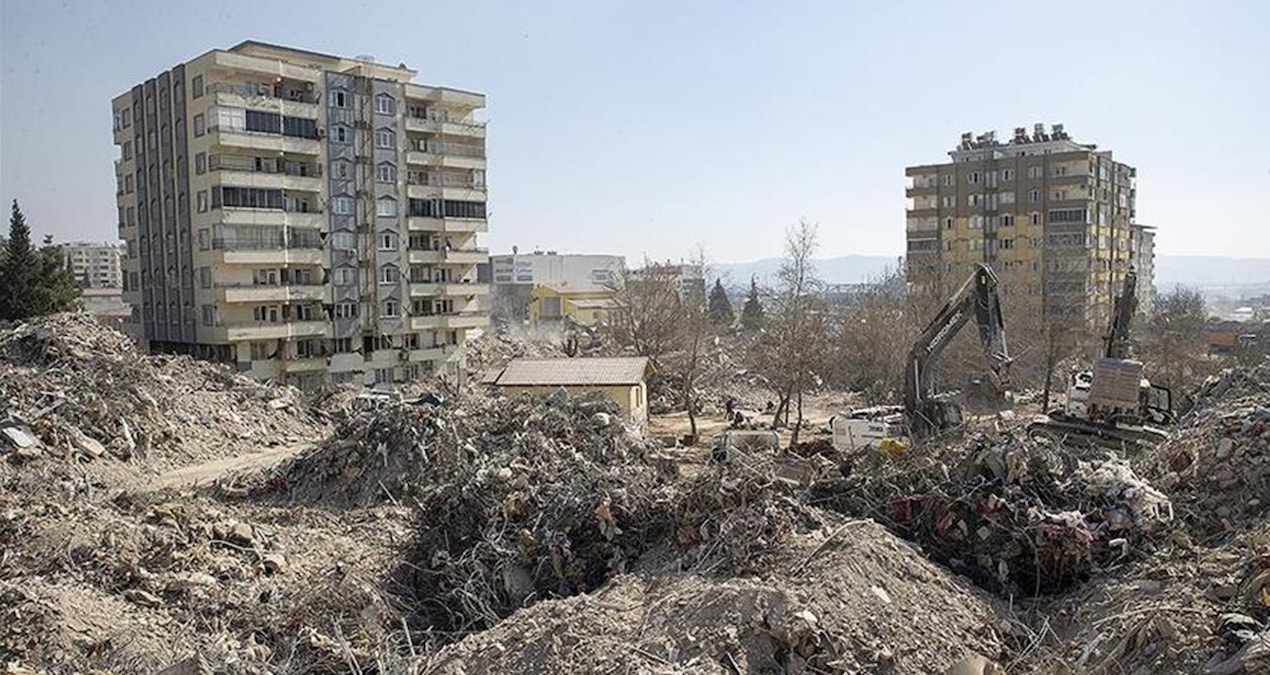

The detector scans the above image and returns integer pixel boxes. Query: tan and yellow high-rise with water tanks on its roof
[906,125,1153,337]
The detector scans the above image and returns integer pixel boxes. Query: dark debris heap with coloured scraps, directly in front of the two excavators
[813,433,1172,596]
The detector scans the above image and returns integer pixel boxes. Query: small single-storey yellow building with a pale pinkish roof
[485,356,649,423]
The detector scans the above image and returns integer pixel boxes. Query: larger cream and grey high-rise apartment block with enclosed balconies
[113,41,489,388]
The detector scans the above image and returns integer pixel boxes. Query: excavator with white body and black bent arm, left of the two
[829,264,1011,451]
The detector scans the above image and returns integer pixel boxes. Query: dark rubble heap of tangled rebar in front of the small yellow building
[265,390,685,634]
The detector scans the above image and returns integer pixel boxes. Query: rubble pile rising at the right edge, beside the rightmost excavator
[1148,365,1270,535]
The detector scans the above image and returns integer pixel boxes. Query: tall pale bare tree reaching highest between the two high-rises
[754,220,828,445]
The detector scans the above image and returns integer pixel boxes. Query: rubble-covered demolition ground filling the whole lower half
[0,314,1270,675]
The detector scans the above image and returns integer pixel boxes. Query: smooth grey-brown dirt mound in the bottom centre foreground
[431,516,1001,674]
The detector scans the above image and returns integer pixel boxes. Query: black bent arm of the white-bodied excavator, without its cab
[904,264,1010,440]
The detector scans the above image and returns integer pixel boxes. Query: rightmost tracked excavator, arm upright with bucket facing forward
[1027,267,1176,447]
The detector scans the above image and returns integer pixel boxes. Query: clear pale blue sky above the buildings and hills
[0,0,1270,262]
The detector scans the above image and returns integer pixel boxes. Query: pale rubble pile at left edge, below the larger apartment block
[0,313,321,469]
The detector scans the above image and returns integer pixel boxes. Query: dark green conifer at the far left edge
[0,200,79,322]
